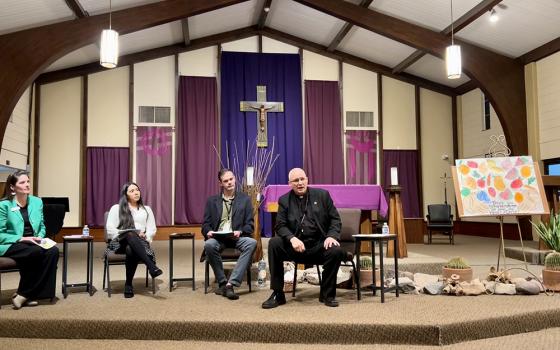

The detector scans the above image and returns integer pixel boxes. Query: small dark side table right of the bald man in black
[352,234,399,303]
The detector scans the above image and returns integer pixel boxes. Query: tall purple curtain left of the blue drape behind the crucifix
[175,77,218,224]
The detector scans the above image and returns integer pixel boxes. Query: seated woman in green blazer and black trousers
[0,170,59,309]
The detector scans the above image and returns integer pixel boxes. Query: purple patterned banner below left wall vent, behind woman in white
[136,126,173,226]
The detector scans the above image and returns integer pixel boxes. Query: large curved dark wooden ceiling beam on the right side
[295,0,528,155]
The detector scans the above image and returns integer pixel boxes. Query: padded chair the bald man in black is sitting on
[292,208,362,297]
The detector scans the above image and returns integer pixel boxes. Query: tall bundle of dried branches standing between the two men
[214,138,280,262]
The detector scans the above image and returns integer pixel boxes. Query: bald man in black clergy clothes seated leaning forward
[262,168,346,309]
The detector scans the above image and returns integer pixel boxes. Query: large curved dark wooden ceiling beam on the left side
[0,0,247,145]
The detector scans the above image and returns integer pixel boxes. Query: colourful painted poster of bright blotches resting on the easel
[451,156,549,217]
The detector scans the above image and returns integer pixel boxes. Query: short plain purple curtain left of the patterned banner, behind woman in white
[86,147,130,227]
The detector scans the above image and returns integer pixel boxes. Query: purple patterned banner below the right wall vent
[346,130,377,184]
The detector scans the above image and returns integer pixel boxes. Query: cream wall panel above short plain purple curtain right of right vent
[382,76,416,149]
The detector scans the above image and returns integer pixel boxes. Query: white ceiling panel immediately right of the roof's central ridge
[266,0,345,46]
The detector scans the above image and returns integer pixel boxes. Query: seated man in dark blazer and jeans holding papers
[202,169,257,300]
